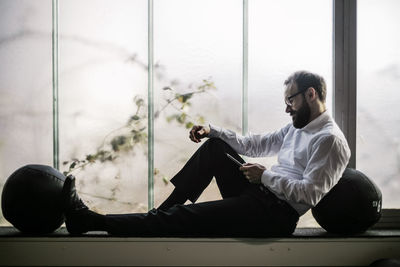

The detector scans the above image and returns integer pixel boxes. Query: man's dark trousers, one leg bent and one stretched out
[106,138,299,237]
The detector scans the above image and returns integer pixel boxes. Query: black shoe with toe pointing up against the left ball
[62,175,90,234]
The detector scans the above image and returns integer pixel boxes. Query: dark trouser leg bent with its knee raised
[171,138,249,203]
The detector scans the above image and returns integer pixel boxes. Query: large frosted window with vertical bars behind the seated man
[0,0,400,229]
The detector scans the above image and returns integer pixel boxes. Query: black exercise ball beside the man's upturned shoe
[1,165,65,234]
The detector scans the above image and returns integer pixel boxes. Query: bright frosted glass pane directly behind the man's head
[248,0,332,227]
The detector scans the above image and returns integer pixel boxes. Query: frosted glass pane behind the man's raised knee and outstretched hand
[154,0,242,206]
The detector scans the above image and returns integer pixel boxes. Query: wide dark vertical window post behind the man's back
[333,0,357,168]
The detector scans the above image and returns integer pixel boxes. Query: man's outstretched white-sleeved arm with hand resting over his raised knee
[189,124,290,157]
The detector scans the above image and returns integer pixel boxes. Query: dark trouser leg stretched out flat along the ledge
[106,185,298,237]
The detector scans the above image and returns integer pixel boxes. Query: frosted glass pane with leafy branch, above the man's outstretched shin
[59,0,147,213]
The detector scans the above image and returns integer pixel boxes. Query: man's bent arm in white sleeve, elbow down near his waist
[261,136,350,207]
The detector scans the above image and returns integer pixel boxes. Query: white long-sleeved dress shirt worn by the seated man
[209,111,350,216]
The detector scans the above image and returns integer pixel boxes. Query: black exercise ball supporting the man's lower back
[312,168,382,235]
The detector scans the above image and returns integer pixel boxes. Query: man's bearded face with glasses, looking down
[285,84,311,129]
